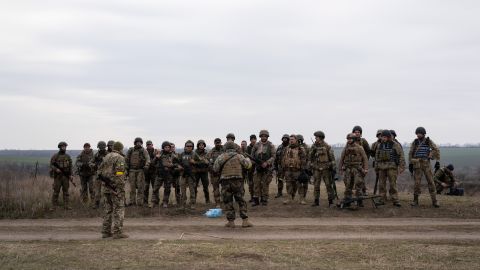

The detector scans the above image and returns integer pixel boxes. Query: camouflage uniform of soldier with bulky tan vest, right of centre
[281,141,308,204]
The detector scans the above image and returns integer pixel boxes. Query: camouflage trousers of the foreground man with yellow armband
[102,190,125,234]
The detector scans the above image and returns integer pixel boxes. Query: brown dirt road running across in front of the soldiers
[0,217,480,241]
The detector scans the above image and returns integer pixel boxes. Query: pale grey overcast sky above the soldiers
[0,0,480,149]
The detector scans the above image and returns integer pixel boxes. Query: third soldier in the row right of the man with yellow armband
[152,142,180,208]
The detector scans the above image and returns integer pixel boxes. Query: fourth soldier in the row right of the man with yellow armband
[179,140,197,210]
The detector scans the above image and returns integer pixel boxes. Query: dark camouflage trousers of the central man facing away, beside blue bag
[221,178,248,221]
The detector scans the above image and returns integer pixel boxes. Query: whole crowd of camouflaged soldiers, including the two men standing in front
[50,126,453,238]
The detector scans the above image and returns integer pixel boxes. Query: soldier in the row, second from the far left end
[75,143,95,206]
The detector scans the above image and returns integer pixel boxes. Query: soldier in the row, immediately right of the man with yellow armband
[125,138,150,206]
